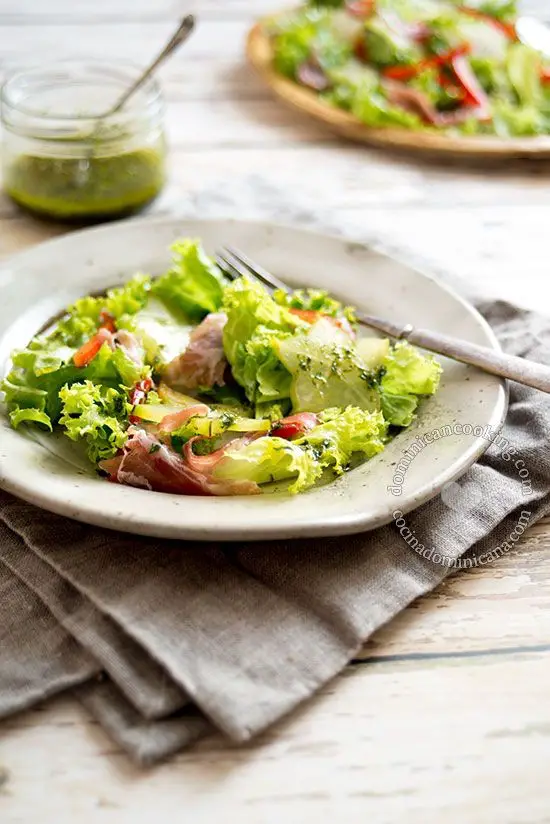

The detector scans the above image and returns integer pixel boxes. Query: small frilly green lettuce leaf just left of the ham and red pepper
[59,380,131,463]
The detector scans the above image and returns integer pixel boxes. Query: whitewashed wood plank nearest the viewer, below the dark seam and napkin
[0,655,550,824]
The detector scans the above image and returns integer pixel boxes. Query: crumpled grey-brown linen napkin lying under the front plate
[0,302,550,764]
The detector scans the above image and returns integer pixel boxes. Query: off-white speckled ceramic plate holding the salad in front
[0,219,506,540]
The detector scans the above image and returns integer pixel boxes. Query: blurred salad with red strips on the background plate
[266,0,550,137]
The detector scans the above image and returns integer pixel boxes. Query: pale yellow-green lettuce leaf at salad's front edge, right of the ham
[213,437,323,493]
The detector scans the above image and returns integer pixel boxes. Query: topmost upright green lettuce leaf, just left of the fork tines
[151,240,226,322]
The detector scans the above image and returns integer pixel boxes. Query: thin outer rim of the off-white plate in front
[0,215,508,542]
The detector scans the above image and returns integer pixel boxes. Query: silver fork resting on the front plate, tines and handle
[216,246,550,392]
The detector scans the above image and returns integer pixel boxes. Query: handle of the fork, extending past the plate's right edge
[408,327,550,392]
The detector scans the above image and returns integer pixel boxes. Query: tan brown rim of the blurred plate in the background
[246,18,550,160]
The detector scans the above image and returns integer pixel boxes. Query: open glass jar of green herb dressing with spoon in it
[1,61,166,223]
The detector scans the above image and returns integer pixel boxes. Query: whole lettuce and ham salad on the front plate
[2,240,441,495]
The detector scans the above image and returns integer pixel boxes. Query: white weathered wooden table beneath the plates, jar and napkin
[0,0,550,824]
